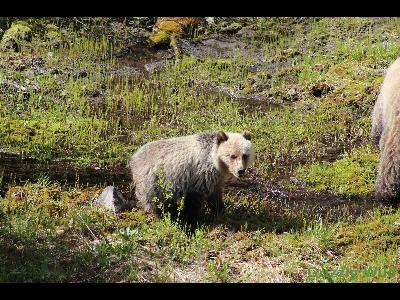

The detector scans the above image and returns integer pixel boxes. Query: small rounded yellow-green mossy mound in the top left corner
[0,21,32,51]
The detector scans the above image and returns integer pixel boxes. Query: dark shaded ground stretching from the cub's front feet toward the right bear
[185,178,387,234]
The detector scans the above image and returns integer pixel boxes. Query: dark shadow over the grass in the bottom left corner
[0,227,125,282]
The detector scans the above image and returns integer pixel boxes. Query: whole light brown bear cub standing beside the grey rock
[129,131,255,222]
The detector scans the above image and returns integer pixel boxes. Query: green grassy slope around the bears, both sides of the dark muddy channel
[0,18,400,282]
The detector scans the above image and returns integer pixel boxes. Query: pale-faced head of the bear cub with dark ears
[216,131,255,178]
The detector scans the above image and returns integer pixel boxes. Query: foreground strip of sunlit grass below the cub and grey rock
[0,178,400,282]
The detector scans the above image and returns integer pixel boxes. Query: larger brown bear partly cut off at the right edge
[371,58,400,205]
